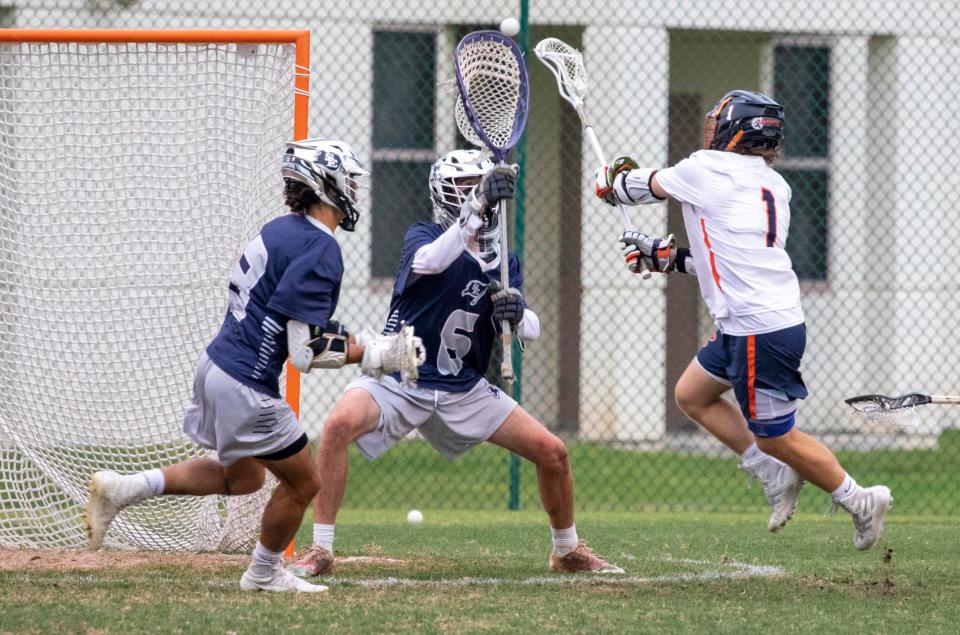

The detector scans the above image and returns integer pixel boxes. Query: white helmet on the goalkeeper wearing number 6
[430,150,500,252]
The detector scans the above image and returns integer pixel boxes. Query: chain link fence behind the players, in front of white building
[9,0,960,514]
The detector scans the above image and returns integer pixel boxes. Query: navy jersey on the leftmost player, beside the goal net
[207,214,343,397]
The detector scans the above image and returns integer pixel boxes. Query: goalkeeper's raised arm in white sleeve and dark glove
[411,165,517,275]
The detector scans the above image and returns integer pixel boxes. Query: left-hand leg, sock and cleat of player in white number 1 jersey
[674,360,803,531]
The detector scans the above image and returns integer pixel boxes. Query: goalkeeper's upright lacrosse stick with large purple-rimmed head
[455,31,529,383]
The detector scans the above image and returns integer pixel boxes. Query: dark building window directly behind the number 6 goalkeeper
[370,31,437,278]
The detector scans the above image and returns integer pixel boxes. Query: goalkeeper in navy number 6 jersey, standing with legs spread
[290,150,621,576]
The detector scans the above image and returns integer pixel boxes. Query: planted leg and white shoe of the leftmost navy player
[240,446,327,593]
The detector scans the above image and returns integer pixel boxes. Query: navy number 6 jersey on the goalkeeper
[384,223,523,392]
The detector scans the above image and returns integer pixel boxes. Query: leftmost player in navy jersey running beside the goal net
[86,139,419,592]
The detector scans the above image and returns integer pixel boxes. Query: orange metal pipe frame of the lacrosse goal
[0,29,310,559]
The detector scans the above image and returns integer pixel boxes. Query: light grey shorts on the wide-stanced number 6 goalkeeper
[345,375,517,459]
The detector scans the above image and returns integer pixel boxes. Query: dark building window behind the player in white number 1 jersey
[773,44,830,281]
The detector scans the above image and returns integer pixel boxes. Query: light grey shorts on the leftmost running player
[183,352,304,465]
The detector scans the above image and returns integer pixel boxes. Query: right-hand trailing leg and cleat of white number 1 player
[757,429,893,549]
